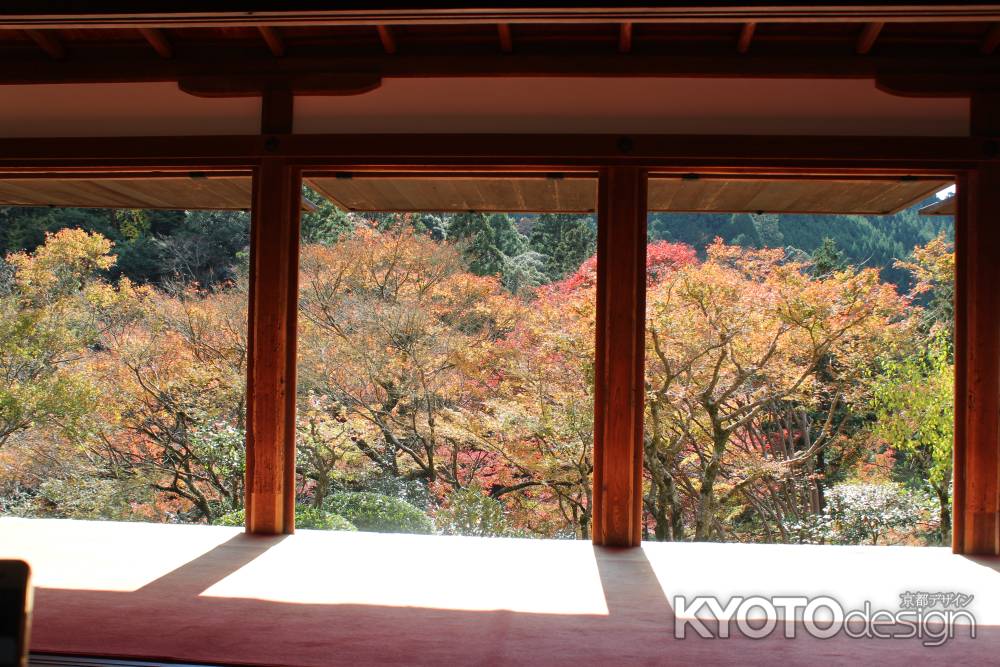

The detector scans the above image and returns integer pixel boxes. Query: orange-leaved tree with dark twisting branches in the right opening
[645,241,907,540]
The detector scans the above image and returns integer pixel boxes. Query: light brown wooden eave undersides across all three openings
[0,172,951,215]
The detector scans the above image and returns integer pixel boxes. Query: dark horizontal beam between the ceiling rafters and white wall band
[0,44,1000,89]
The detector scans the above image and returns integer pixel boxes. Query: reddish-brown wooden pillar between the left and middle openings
[246,158,302,535]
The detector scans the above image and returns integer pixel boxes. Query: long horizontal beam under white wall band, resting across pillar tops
[0,134,984,168]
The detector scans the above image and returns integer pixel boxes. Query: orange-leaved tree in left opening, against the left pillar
[90,268,247,522]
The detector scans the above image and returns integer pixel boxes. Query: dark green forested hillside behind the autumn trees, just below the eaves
[0,193,953,288]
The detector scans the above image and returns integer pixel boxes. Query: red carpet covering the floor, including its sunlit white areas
[0,519,1000,667]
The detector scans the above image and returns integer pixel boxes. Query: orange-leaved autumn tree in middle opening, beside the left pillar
[299,227,515,500]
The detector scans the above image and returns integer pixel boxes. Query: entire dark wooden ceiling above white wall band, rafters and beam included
[0,7,1000,94]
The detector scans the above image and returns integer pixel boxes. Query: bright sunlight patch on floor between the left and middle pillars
[202,530,608,615]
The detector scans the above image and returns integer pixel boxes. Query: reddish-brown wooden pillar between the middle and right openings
[593,167,646,546]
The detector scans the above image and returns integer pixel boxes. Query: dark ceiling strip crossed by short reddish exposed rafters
[0,20,1000,65]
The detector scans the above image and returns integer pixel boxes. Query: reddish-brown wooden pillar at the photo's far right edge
[952,164,1000,554]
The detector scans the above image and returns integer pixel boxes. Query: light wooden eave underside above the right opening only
[649,174,951,215]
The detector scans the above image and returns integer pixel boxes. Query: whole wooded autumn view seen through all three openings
[0,198,954,544]
